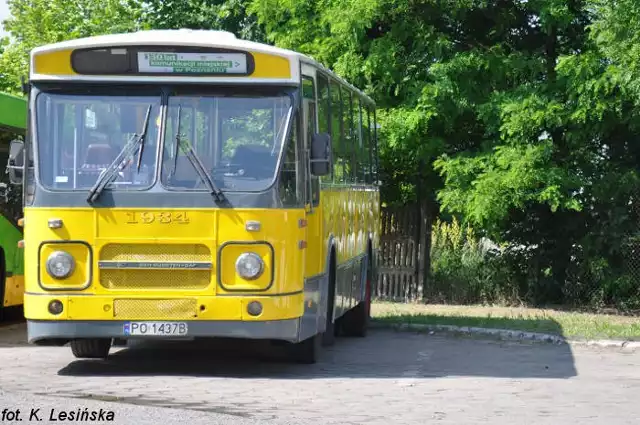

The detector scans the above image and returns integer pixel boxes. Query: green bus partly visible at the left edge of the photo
[0,93,27,319]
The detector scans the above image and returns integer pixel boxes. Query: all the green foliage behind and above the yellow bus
[0,0,640,305]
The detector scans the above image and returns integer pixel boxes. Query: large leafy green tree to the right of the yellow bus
[251,0,640,302]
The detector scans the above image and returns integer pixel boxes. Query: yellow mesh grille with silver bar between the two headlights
[99,244,211,290]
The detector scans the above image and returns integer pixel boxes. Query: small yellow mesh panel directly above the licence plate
[113,299,196,320]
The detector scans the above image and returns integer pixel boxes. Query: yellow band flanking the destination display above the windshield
[33,50,291,79]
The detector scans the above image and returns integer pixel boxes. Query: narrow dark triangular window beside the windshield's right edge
[278,117,304,208]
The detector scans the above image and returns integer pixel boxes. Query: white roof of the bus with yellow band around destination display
[30,29,373,103]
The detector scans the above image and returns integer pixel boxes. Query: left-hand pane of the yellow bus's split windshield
[36,90,161,190]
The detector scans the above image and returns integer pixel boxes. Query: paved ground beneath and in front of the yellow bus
[0,325,640,425]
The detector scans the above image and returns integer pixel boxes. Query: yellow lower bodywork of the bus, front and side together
[24,188,379,321]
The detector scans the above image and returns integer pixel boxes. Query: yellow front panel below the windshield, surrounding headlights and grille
[24,208,305,320]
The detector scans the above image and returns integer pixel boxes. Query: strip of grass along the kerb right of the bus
[371,302,640,340]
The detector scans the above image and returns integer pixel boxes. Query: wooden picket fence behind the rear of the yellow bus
[373,205,431,302]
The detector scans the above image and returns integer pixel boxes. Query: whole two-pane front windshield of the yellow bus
[35,87,293,192]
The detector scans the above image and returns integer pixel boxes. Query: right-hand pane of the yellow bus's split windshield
[161,89,293,192]
